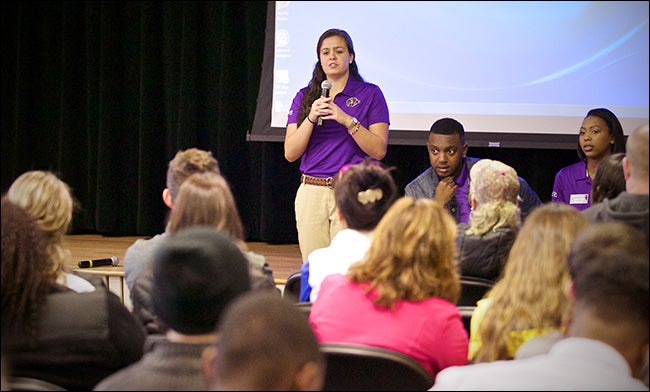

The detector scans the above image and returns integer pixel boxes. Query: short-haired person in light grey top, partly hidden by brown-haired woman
[124,148,220,291]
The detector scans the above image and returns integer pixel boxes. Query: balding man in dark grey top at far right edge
[583,124,650,244]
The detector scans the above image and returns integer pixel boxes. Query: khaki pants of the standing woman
[295,183,344,262]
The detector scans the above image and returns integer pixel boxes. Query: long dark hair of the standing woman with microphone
[298,29,363,124]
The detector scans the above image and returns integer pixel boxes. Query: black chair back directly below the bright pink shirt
[320,343,434,391]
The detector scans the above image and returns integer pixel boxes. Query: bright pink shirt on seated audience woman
[309,274,469,377]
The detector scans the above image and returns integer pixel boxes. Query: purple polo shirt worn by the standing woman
[287,78,390,177]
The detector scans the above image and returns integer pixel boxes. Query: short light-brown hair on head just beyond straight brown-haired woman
[167,148,220,201]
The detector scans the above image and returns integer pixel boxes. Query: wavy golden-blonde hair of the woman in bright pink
[347,197,460,308]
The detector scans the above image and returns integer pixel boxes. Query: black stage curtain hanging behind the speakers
[1,1,579,243]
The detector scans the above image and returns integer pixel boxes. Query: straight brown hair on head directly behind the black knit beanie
[169,172,244,241]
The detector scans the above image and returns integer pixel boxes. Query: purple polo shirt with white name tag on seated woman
[551,161,591,211]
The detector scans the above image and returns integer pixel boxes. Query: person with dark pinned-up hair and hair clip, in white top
[300,160,399,302]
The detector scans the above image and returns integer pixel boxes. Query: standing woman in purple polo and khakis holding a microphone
[284,29,390,262]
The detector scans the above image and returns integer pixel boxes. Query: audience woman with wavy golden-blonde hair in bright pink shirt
[309,197,468,376]
